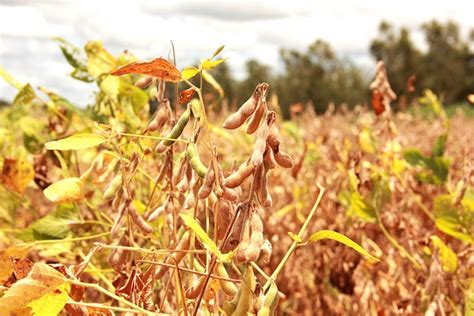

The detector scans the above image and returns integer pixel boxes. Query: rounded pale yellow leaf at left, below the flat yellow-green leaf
[43,178,84,203]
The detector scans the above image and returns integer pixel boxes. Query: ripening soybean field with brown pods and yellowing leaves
[0,40,474,316]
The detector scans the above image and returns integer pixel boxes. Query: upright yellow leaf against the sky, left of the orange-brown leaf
[85,41,117,79]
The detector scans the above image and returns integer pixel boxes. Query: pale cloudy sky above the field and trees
[0,0,474,105]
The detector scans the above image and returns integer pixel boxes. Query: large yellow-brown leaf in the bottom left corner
[0,262,70,316]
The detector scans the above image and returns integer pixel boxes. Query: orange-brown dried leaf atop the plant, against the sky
[111,57,181,82]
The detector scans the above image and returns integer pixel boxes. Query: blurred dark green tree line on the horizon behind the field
[213,21,474,116]
